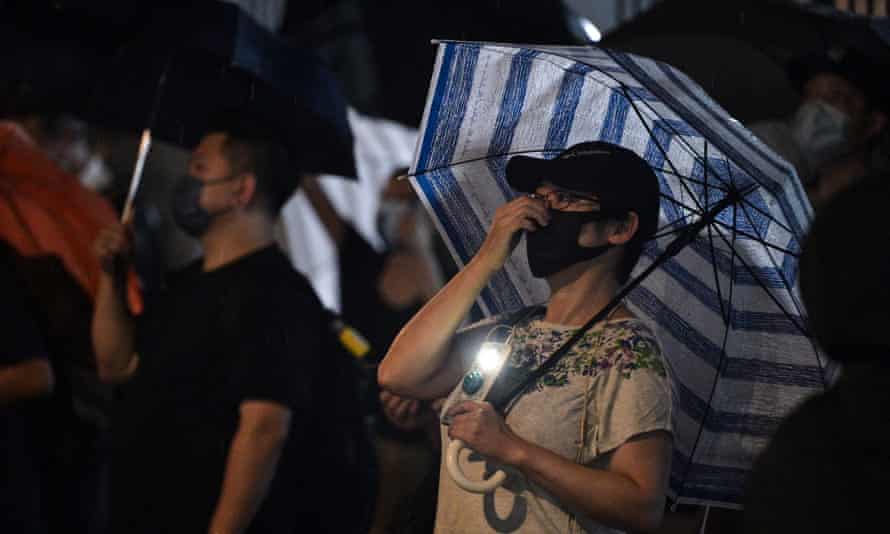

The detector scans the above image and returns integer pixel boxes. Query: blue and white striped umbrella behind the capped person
[412,42,833,507]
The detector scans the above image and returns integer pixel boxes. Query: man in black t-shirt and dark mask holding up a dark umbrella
[93,118,367,533]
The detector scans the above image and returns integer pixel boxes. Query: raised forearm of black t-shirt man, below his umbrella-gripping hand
[92,273,134,382]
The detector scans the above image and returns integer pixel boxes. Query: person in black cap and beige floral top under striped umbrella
[378,142,672,533]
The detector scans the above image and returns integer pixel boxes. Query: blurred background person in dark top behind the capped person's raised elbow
[302,169,454,533]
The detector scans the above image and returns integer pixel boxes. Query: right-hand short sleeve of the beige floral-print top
[589,321,672,457]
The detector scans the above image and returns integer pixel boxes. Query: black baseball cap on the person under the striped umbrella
[507,141,661,240]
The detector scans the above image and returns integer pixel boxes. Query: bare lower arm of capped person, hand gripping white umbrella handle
[449,402,671,532]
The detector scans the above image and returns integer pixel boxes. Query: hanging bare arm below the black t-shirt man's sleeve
[209,401,291,534]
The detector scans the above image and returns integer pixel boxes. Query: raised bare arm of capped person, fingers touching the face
[377,197,548,399]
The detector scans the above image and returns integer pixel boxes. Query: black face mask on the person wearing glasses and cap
[525,209,614,278]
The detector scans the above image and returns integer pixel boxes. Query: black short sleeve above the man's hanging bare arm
[234,296,325,410]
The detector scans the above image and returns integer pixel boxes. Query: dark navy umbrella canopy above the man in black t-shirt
[89,2,356,180]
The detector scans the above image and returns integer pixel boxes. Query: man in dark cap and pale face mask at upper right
[751,50,888,209]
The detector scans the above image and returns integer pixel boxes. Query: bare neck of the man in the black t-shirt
[201,212,275,271]
